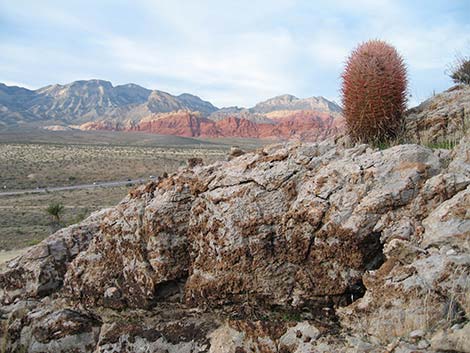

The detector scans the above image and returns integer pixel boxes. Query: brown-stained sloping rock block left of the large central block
[64,172,197,308]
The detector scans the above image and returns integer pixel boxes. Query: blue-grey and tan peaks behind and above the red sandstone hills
[0,79,341,126]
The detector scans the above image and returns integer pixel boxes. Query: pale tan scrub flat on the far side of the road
[0,144,226,190]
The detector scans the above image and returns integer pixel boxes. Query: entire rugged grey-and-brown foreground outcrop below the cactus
[0,137,470,353]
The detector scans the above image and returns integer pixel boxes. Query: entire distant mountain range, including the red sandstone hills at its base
[0,80,344,140]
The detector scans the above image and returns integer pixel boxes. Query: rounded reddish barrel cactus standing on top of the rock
[341,40,407,142]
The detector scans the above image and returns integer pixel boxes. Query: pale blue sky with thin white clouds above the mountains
[0,0,470,106]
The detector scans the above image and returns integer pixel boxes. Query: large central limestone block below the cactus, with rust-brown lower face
[186,145,441,306]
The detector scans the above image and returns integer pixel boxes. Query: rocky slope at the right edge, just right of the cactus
[405,85,470,145]
